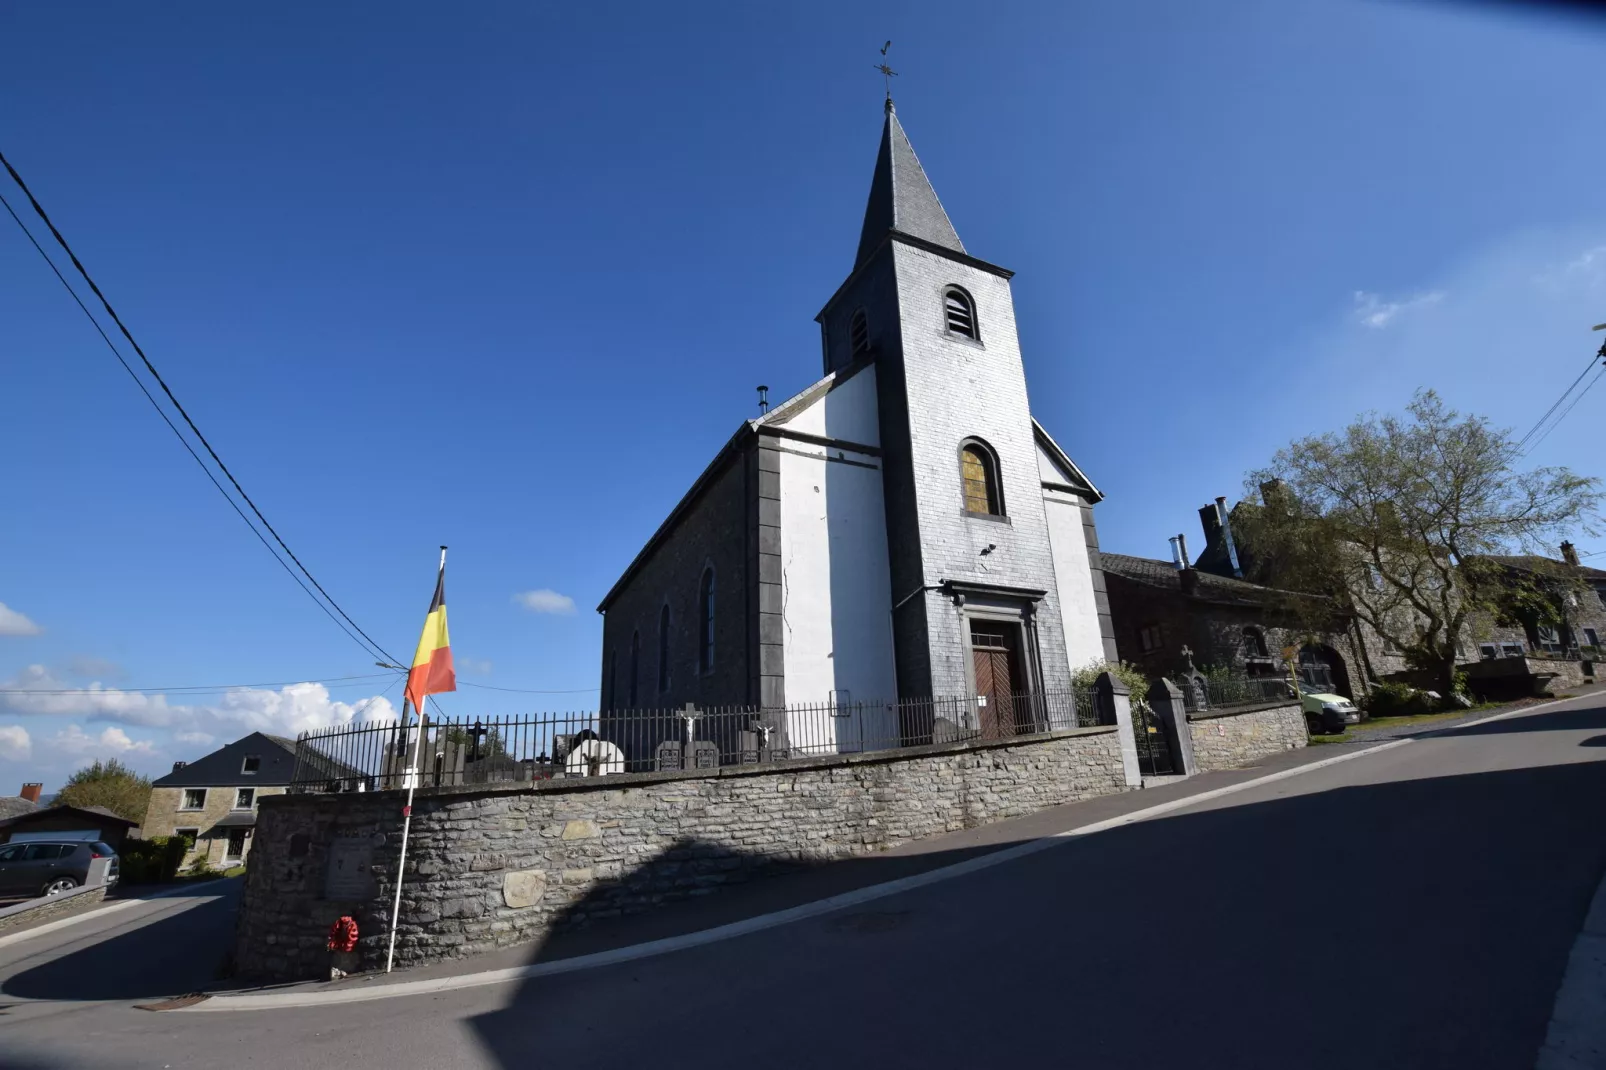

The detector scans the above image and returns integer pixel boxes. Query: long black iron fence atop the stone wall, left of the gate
[291,689,1100,792]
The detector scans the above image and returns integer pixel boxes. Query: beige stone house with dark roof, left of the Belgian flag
[141,733,296,869]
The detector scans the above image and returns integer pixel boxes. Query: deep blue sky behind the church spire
[0,0,1606,792]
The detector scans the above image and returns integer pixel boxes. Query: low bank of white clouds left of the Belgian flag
[0,665,397,739]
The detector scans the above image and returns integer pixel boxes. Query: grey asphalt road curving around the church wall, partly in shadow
[0,697,1606,1070]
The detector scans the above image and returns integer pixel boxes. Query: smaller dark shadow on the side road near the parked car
[0,880,239,1002]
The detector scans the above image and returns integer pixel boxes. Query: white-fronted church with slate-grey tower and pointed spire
[597,98,1116,749]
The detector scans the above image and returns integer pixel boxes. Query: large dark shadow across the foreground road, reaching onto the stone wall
[466,742,1606,1070]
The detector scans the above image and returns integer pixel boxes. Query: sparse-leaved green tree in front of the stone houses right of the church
[1235,390,1601,696]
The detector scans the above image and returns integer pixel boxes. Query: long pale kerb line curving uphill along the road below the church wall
[182,687,1571,1014]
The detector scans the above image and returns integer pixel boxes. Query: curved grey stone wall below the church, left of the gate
[234,725,1126,980]
